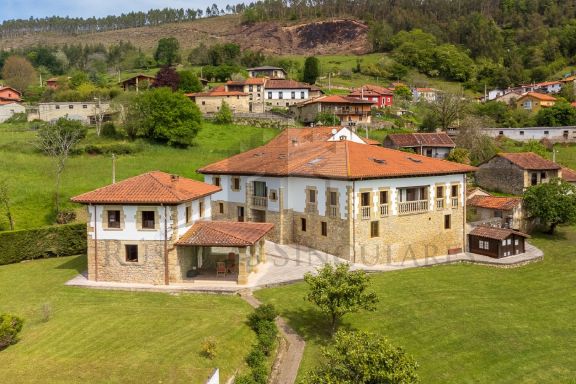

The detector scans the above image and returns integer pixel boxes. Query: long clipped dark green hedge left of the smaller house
[0,224,86,265]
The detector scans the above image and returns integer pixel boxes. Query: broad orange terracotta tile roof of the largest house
[198,140,476,180]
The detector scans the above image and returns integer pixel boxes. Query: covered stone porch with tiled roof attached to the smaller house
[170,221,274,285]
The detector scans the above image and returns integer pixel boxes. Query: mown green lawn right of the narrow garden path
[256,227,576,383]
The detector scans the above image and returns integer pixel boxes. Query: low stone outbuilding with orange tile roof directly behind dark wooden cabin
[466,196,531,232]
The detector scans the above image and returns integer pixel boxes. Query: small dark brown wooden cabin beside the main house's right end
[468,226,530,258]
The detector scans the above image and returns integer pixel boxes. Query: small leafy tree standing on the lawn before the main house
[304,263,378,333]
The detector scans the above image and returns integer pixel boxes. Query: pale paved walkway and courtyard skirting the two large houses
[66,242,543,293]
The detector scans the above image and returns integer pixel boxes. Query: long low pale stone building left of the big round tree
[28,101,114,124]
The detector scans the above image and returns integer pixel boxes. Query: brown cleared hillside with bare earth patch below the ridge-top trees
[0,16,370,55]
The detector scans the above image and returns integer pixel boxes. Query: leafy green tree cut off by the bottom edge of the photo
[304,331,419,384]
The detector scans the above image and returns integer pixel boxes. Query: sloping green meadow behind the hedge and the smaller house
[0,123,277,229]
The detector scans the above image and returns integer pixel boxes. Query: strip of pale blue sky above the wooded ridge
[0,0,240,22]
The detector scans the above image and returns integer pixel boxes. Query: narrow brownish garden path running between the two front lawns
[241,291,306,384]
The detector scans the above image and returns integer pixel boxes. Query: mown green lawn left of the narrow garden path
[0,256,255,384]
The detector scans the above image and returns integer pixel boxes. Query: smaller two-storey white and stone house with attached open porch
[72,172,273,285]
